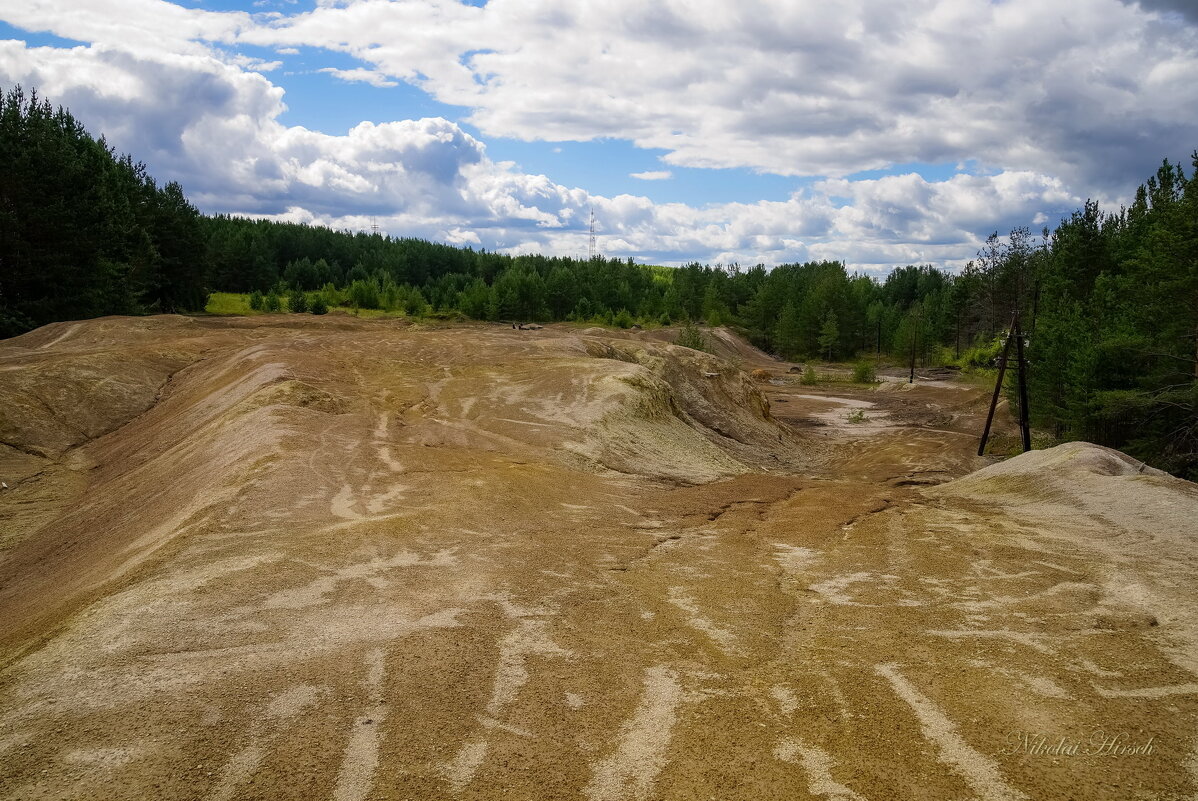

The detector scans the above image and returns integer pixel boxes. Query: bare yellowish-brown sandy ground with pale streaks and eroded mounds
[0,316,1198,801]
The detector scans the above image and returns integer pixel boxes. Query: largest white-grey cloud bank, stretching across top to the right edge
[237,0,1198,189]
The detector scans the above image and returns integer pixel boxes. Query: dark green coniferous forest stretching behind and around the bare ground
[0,87,1198,479]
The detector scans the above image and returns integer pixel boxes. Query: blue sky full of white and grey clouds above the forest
[0,0,1198,275]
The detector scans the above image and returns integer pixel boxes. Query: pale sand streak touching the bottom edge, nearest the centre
[585,665,683,801]
